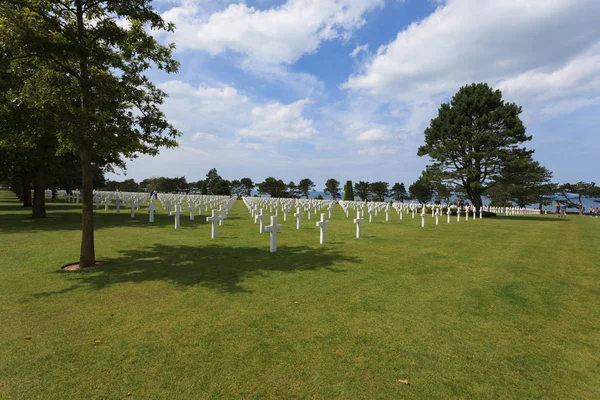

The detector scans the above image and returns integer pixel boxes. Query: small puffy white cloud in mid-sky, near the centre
[236,99,318,140]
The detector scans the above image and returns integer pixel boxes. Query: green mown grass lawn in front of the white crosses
[0,192,600,399]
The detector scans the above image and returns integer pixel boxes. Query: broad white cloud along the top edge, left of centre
[163,0,384,64]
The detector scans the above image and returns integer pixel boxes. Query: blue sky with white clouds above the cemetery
[107,0,600,190]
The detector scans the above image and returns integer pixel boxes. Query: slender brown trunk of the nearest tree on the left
[79,149,96,268]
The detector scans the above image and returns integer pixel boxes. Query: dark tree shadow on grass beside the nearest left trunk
[43,244,362,297]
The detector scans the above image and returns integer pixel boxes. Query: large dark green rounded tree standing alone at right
[418,83,533,211]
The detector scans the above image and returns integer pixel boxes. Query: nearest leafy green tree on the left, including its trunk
[0,0,178,267]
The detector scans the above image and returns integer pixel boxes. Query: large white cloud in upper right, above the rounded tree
[344,0,600,104]
